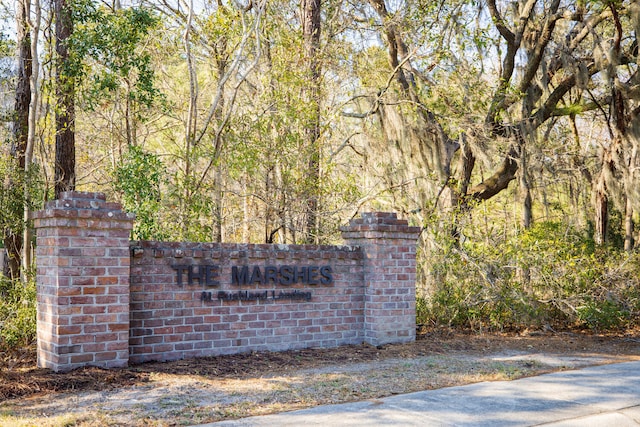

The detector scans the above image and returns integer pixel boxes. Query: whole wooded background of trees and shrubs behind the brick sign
[0,0,640,334]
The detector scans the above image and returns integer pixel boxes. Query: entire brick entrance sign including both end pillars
[34,192,419,371]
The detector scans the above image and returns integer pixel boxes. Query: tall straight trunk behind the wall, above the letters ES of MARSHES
[302,0,321,243]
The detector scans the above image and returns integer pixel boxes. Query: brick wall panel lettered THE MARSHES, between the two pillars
[129,242,364,363]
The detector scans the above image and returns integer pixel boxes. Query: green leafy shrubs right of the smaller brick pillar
[420,222,640,330]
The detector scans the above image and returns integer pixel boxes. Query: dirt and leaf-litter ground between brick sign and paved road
[0,329,640,427]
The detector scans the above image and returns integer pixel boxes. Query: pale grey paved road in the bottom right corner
[201,362,640,427]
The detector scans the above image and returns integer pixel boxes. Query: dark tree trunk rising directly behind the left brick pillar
[55,0,76,198]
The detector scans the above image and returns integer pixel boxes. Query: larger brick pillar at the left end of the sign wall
[34,191,134,372]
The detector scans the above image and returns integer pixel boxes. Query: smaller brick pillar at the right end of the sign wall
[341,212,420,345]
